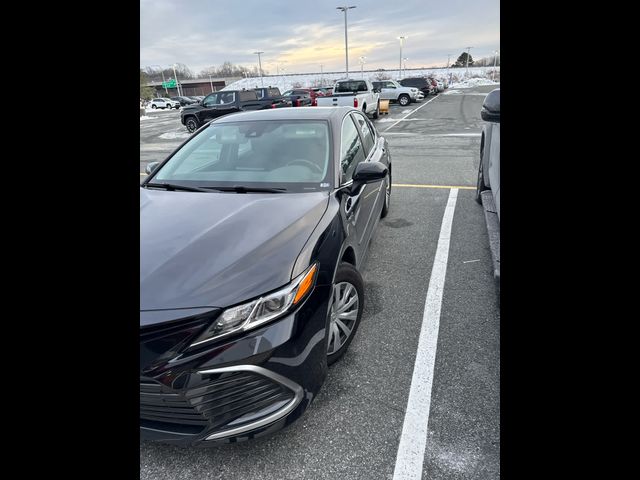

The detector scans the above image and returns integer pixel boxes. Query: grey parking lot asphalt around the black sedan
[140,87,500,480]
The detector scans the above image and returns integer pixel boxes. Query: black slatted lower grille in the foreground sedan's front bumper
[140,371,294,434]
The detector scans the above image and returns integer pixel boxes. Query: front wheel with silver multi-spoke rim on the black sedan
[327,262,364,365]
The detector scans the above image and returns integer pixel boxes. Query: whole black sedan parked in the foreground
[140,107,391,446]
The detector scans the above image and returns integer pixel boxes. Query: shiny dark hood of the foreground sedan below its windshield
[140,188,328,311]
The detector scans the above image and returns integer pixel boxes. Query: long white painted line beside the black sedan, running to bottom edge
[393,188,458,480]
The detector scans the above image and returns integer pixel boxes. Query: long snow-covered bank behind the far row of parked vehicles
[223,67,500,92]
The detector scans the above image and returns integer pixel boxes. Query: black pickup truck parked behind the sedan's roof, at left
[180,90,274,133]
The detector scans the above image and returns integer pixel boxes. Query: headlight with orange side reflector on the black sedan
[191,263,318,347]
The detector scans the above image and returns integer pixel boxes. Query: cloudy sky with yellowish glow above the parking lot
[140,0,500,74]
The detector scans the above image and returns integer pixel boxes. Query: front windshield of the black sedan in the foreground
[150,120,332,192]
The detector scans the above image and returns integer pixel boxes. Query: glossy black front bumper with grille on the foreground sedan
[140,286,331,446]
